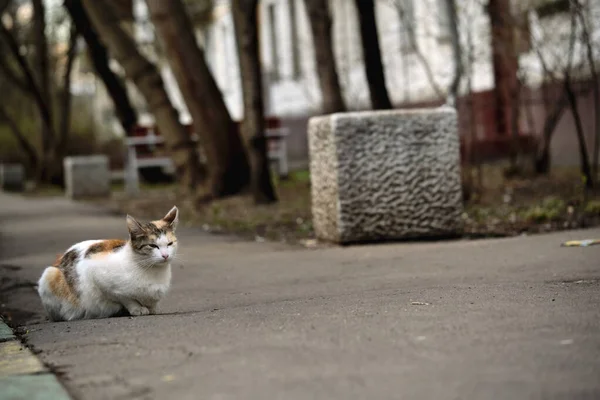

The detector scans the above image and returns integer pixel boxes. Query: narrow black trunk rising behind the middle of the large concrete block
[354,0,392,110]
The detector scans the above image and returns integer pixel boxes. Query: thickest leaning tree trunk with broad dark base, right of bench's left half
[146,0,250,197]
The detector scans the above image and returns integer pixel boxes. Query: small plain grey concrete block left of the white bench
[63,155,110,199]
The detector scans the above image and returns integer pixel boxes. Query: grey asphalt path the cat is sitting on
[0,195,600,400]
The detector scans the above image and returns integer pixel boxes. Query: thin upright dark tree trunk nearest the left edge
[32,0,56,180]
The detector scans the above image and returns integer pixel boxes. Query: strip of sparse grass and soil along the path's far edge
[72,166,600,243]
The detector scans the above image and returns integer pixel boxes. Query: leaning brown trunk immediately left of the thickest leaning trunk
[83,0,201,190]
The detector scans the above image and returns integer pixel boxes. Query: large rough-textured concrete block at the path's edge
[308,107,463,243]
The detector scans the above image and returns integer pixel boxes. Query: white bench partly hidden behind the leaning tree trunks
[125,127,289,194]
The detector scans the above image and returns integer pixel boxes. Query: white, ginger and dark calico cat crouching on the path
[38,207,179,321]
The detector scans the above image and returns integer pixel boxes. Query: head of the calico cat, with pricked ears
[127,207,179,264]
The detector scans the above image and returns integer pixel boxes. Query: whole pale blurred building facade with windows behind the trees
[86,0,600,167]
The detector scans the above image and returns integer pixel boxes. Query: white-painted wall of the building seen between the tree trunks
[85,0,600,135]
